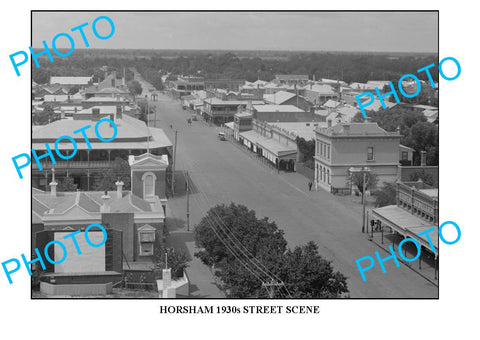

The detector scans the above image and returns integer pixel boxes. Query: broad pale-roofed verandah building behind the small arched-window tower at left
[32,112,172,191]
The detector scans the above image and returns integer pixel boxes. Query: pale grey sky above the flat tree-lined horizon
[32,12,438,53]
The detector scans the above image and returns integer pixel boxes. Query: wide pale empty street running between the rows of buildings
[133,75,438,298]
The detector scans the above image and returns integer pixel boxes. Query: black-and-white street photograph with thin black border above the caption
[29,11,442,299]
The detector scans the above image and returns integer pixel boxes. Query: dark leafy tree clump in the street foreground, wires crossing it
[195,203,348,298]
